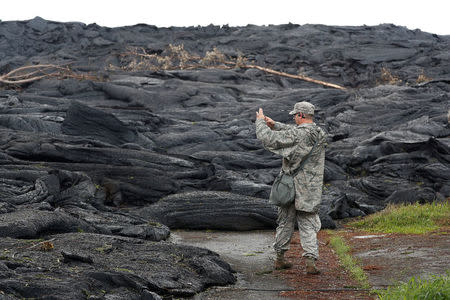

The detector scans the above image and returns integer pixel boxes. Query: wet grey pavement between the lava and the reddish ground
[171,231,292,300]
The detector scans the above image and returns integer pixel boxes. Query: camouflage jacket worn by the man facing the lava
[256,119,326,212]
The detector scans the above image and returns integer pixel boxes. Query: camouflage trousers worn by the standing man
[273,204,321,259]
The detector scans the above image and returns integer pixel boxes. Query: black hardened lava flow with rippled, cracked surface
[0,17,450,299]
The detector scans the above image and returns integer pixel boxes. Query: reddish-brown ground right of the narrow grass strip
[344,230,450,288]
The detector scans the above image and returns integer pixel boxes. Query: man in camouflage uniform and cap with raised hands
[256,102,326,274]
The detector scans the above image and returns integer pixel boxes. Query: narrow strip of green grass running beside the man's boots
[330,233,370,289]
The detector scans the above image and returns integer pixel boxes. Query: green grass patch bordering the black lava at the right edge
[348,202,450,234]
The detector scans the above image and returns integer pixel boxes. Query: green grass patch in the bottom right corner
[376,272,450,300]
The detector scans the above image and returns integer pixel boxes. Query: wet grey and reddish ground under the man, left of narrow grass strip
[171,230,371,300]
